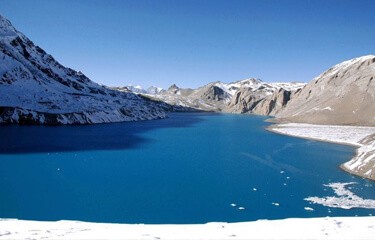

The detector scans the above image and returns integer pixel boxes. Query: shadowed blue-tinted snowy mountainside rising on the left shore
[0,15,166,124]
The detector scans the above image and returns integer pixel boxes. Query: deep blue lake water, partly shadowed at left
[0,113,375,223]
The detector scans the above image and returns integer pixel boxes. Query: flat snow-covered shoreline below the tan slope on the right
[269,123,375,180]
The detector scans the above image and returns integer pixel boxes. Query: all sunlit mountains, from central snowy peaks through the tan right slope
[116,55,375,126]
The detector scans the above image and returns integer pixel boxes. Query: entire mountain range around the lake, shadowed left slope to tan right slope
[0,15,375,125]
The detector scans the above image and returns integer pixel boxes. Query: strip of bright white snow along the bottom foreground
[0,217,375,240]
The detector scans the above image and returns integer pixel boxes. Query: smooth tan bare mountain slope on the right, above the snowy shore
[276,55,375,125]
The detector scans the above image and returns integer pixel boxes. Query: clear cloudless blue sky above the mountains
[0,0,375,88]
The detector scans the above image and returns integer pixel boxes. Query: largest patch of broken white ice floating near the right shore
[305,182,375,209]
